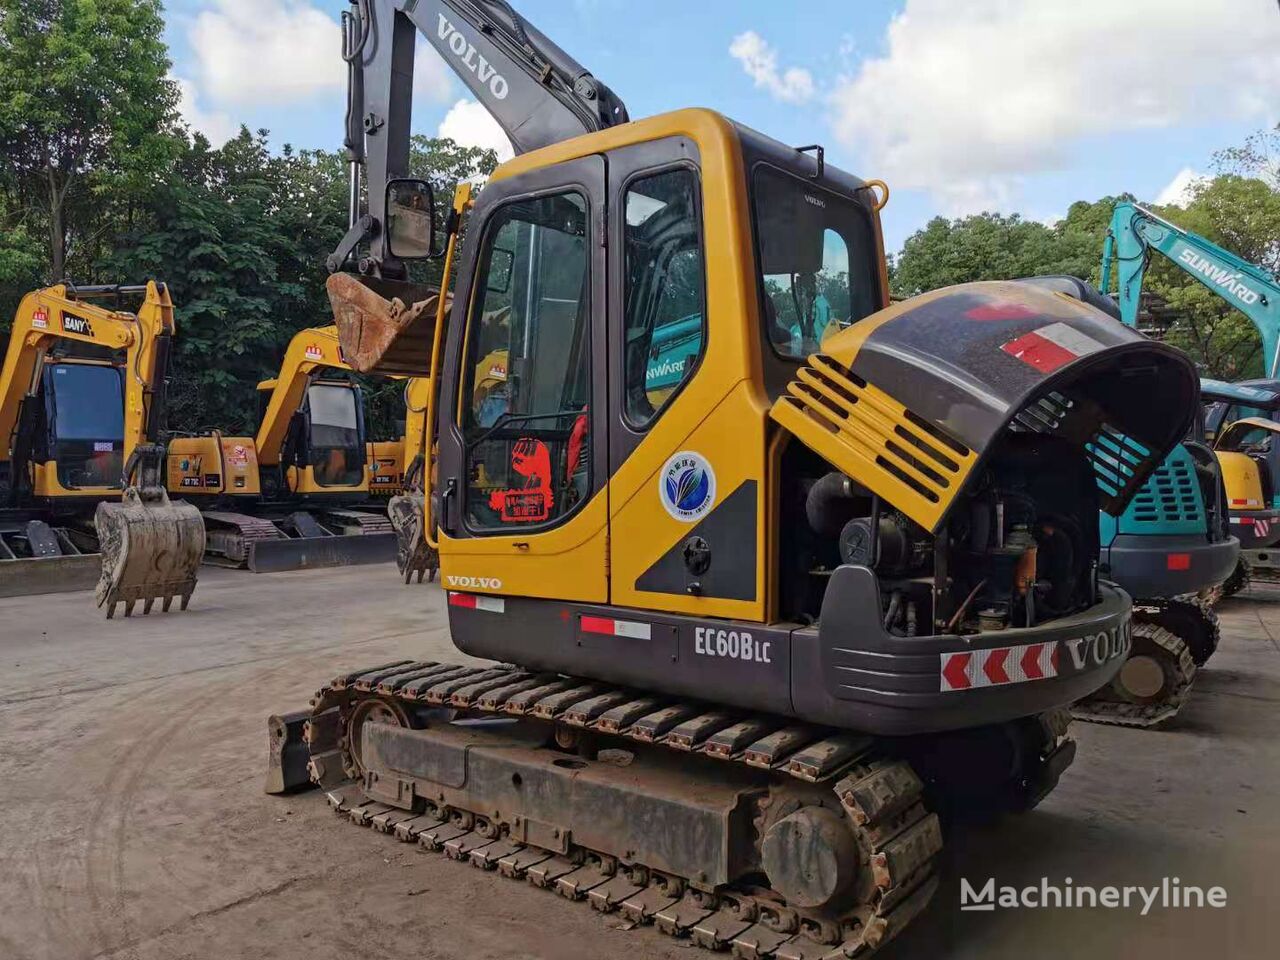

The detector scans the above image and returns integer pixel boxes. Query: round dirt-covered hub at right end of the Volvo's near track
[760,806,858,910]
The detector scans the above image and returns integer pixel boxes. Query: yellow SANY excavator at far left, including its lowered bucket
[0,282,204,617]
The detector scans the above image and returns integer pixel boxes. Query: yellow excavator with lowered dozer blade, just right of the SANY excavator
[166,326,396,572]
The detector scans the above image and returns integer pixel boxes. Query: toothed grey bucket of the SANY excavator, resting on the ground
[93,444,205,620]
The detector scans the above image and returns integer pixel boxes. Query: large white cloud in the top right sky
[831,0,1280,214]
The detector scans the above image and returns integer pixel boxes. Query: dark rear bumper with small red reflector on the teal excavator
[1101,527,1240,599]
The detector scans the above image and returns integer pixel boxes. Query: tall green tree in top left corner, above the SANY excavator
[0,0,178,285]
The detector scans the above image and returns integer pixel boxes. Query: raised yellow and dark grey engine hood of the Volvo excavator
[771,280,1199,531]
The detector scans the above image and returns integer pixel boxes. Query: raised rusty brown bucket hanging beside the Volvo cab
[325,274,439,376]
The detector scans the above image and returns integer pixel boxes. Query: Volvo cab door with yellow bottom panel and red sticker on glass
[435,156,609,603]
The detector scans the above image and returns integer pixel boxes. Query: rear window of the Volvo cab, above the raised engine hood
[753,166,878,360]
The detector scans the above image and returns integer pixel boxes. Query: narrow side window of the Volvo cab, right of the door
[623,168,705,429]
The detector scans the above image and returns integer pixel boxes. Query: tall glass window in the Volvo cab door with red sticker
[460,191,591,532]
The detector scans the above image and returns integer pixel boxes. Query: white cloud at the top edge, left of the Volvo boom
[188,0,347,105]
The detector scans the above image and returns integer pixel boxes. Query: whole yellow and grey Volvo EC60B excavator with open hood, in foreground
[268,0,1198,960]
